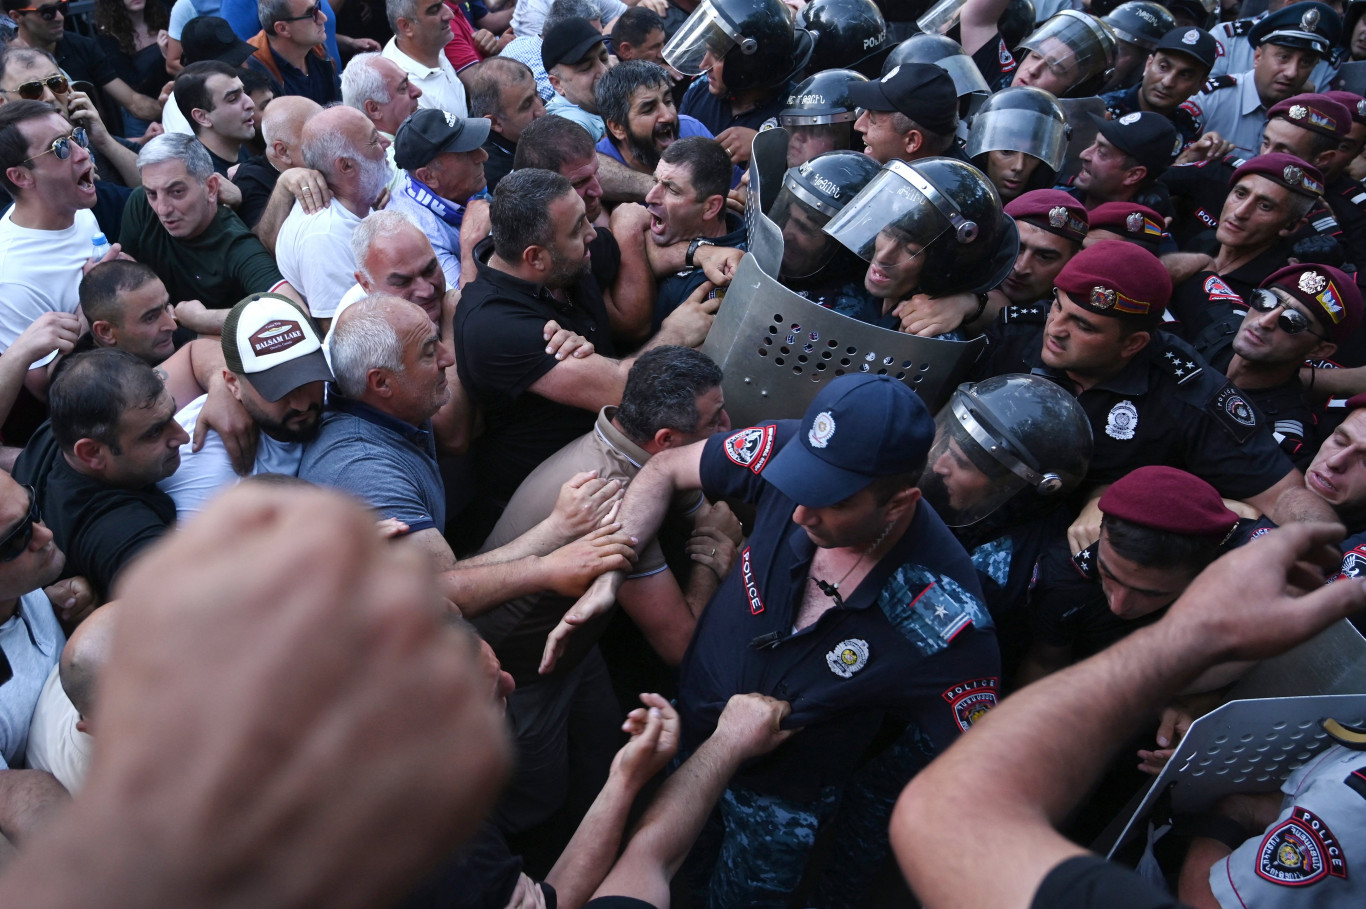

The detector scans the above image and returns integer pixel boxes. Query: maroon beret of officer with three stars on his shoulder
[1053,241,1172,323]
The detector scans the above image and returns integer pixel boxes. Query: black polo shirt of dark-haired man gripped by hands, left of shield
[455,237,616,506]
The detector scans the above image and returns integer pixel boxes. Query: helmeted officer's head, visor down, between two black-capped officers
[964,86,1071,202]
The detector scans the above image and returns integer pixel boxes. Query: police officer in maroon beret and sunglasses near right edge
[1191,264,1362,467]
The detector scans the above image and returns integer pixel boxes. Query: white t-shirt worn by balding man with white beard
[275,200,361,318]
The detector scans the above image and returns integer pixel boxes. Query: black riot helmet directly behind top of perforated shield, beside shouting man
[768,152,881,280]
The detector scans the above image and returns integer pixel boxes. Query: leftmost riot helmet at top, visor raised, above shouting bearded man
[664,0,813,92]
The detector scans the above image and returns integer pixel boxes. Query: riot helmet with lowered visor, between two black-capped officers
[964,86,1072,189]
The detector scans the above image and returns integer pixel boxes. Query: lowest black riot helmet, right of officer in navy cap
[919,375,1091,528]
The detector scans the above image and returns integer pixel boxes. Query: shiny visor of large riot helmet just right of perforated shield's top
[825,161,949,261]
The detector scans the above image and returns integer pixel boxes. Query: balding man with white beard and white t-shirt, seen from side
[275,107,392,331]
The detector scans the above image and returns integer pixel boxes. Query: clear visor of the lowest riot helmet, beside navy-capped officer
[919,391,1026,528]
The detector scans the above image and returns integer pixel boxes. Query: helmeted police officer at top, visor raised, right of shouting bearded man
[664,0,813,164]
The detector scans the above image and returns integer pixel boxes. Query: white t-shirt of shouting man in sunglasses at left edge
[0,206,99,368]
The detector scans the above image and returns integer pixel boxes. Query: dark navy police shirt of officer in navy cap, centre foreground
[679,420,1000,801]
